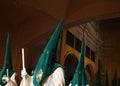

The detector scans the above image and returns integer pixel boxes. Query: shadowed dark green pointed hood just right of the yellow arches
[93,60,101,86]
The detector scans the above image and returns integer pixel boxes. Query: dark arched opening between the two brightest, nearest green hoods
[64,54,78,86]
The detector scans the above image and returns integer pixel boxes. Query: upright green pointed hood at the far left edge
[0,33,14,86]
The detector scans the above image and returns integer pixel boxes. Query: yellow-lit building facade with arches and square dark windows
[57,23,98,84]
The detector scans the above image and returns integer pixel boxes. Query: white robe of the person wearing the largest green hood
[20,67,65,86]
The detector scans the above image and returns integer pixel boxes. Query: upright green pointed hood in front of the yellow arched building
[70,39,86,86]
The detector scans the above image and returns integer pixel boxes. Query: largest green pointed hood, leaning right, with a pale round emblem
[33,20,62,86]
